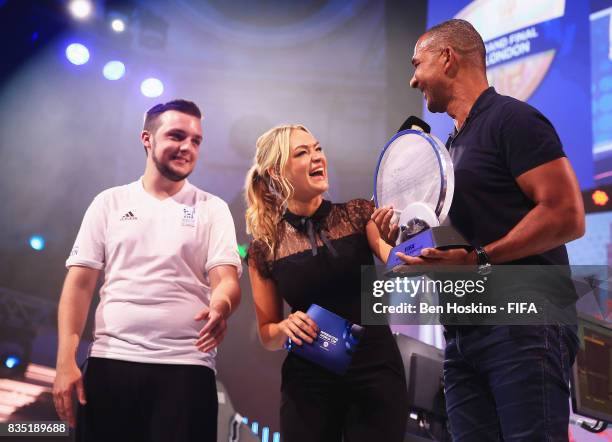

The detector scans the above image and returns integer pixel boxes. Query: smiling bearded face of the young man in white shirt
[142,110,202,181]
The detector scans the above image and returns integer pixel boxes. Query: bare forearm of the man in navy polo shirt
[485,204,584,264]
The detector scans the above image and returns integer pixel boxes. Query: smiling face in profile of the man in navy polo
[410,36,450,112]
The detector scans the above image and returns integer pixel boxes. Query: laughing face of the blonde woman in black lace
[284,129,329,201]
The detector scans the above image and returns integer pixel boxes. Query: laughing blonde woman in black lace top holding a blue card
[245,125,407,442]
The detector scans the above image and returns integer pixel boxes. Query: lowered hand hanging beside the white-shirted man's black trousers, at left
[53,363,86,428]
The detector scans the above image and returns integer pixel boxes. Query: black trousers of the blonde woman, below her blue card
[280,327,408,442]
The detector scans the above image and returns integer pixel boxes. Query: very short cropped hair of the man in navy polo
[424,18,487,69]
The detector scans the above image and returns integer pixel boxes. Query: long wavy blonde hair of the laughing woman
[244,124,310,253]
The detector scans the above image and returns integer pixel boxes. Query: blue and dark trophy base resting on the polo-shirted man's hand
[386,226,472,272]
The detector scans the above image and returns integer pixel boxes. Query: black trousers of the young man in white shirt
[76,358,218,442]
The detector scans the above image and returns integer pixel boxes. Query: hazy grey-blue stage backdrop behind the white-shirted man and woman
[0,0,426,431]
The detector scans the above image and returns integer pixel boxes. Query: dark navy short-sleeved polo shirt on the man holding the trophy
[446,87,568,265]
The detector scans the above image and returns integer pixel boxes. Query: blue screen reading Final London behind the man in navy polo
[423,0,596,188]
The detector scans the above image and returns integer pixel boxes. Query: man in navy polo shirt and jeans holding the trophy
[372,20,584,441]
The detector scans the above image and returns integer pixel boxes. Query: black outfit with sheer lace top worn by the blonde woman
[249,199,407,442]
